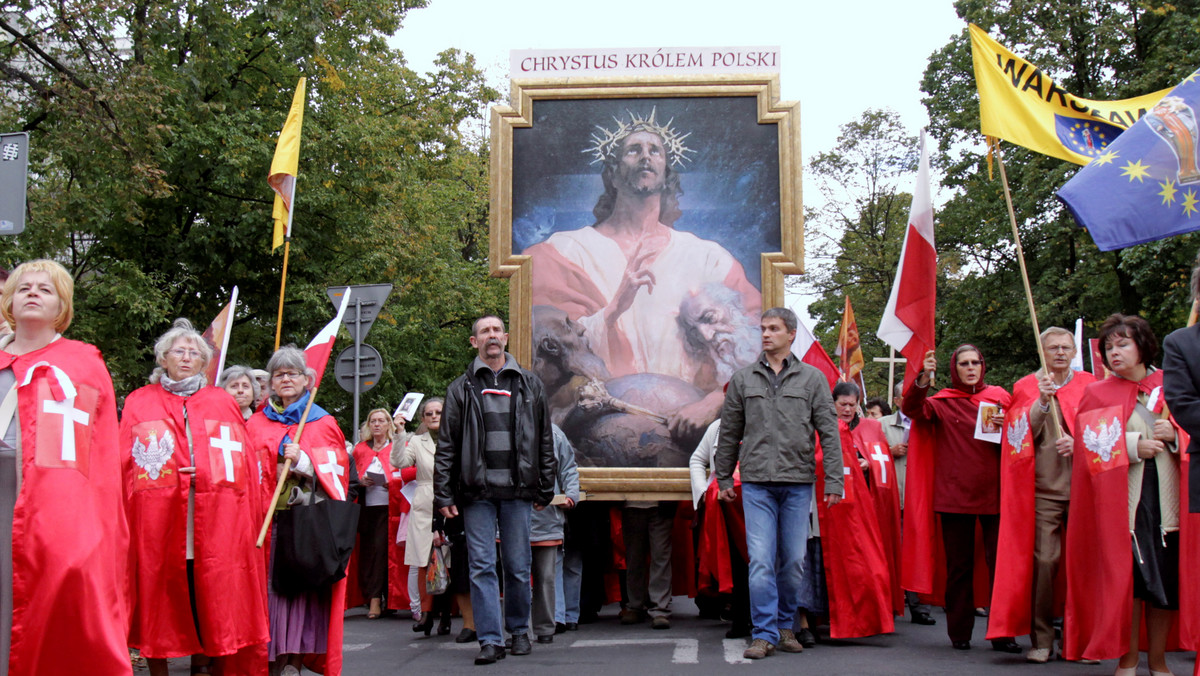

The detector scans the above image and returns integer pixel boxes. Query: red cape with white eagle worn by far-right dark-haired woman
[1063,371,1200,659]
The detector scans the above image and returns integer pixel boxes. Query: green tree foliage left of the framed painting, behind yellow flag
[0,0,505,437]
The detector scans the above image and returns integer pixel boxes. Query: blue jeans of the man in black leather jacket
[460,499,533,646]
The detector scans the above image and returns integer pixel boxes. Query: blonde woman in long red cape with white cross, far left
[0,261,132,676]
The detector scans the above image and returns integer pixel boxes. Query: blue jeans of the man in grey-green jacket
[742,483,812,644]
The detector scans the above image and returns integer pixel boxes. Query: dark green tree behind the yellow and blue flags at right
[922,0,1200,384]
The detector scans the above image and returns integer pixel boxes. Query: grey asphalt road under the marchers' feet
[150,597,1194,676]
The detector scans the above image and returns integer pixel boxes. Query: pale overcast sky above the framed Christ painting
[392,0,965,330]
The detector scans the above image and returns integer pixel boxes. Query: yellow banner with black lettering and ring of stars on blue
[971,24,1170,164]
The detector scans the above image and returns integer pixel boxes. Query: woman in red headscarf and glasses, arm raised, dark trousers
[900,345,1021,653]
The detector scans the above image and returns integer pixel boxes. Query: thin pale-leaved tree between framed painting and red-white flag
[803,109,918,395]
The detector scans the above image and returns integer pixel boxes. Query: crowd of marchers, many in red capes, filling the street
[0,261,1200,676]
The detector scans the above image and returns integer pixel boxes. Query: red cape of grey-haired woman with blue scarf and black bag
[246,411,350,676]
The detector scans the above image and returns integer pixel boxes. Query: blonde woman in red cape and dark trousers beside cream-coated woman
[347,408,396,620]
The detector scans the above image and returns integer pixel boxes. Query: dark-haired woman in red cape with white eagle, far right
[1063,315,1200,676]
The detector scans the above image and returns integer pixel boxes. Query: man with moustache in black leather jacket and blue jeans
[433,316,557,664]
